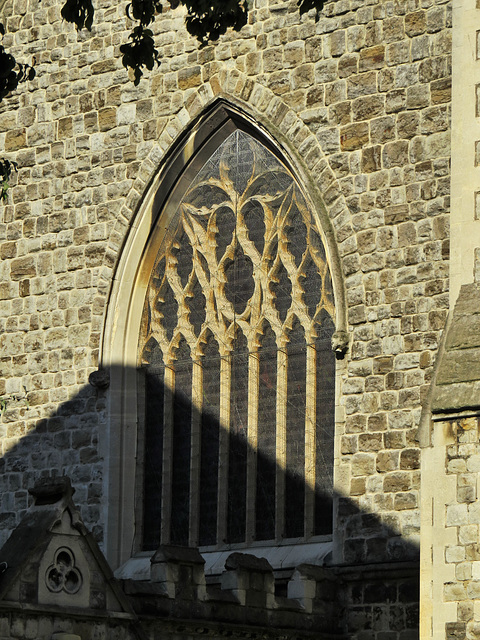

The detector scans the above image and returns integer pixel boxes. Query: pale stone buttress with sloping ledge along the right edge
[420,0,480,639]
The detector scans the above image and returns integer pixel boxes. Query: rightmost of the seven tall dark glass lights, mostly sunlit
[315,311,335,535]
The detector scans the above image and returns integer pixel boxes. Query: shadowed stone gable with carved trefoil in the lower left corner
[0,477,144,640]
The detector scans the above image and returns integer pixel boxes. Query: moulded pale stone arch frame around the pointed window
[102,101,345,566]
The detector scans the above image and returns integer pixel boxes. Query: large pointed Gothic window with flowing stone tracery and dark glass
[138,128,335,550]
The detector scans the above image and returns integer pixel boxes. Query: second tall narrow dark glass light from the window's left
[170,338,192,545]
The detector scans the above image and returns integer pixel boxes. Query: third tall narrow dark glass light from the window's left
[199,334,220,545]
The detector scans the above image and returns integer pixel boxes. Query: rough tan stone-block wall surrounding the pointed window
[0,0,451,576]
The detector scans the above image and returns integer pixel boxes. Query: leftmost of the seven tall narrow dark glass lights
[139,339,165,550]
